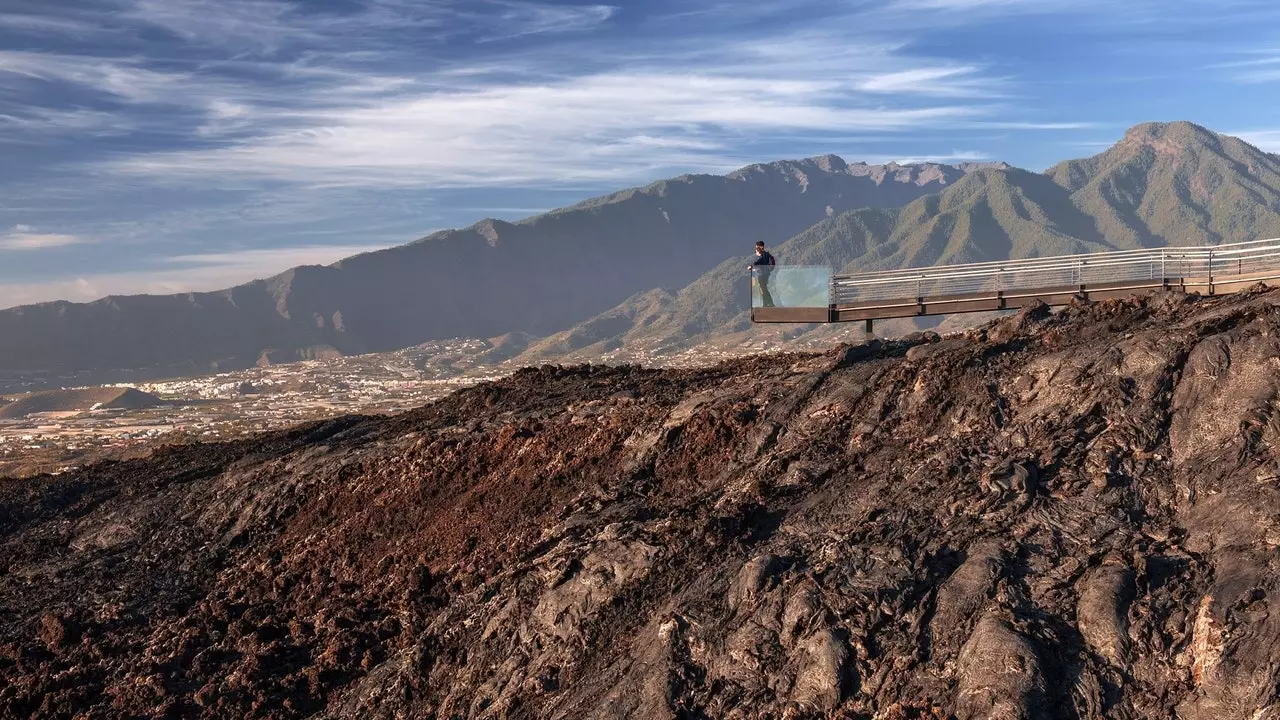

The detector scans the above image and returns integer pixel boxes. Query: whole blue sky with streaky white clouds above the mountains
[0,0,1280,307]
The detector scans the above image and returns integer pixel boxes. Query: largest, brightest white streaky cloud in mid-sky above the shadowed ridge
[113,73,984,186]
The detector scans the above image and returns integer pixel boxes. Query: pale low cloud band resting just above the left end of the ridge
[0,245,383,307]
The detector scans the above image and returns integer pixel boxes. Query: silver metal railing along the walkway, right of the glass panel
[831,240,1280,306]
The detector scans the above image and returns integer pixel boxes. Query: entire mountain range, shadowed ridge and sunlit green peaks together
[0,123,1280,377]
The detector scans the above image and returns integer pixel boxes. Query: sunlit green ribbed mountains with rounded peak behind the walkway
[513,123,1280,364]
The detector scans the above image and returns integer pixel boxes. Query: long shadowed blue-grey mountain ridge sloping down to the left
[0,154,988,379]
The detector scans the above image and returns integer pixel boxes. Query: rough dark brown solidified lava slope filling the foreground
[0,292,1280,720]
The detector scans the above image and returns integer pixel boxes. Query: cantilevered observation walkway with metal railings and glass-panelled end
[751,240,1280,331]
